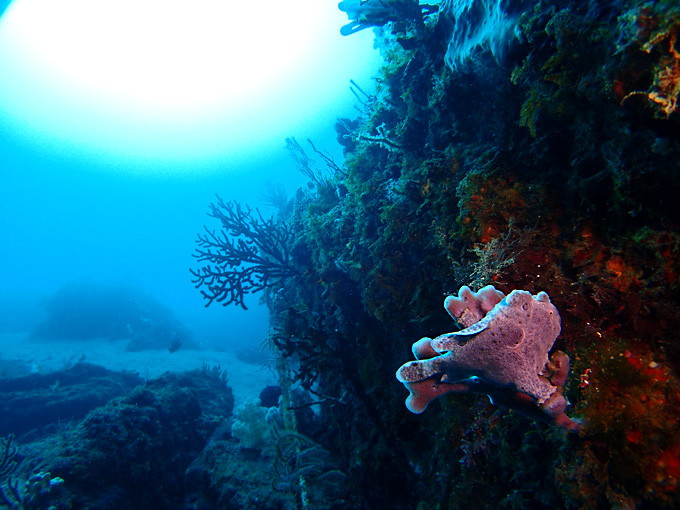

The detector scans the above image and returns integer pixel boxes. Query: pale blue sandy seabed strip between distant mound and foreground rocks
[0,333,277,405]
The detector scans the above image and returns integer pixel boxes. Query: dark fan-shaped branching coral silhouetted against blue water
[190,196,297,310]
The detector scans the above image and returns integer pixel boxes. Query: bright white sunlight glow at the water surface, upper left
[0,0,376,171]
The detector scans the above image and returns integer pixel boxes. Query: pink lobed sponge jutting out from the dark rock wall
[397,285,580,431]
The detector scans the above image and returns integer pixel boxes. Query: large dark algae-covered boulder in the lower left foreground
[22,369,233,510]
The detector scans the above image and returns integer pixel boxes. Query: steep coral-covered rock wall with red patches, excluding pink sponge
[270,0,680,508]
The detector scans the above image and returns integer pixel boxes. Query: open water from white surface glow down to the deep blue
[0,0,377,355]
